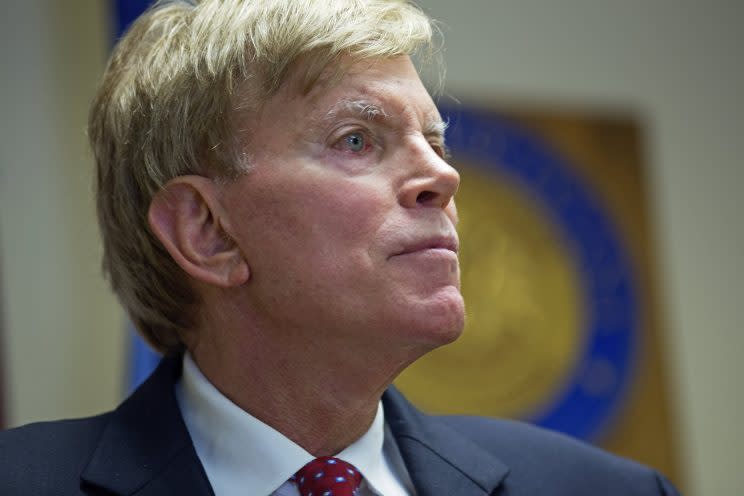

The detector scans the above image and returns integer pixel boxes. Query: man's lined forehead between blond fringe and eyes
[236,56,446,161]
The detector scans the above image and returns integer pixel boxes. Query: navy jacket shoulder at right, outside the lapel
[438,416,678,496]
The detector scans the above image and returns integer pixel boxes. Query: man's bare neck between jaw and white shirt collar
[185,312,420,456]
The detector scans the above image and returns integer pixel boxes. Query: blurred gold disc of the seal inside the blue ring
[396,164,583,417]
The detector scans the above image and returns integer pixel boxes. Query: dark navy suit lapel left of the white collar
[82,356,214,496]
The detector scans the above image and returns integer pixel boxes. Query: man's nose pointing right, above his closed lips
[400,139,460,209]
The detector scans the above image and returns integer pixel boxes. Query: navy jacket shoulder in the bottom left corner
[0,414,110,496]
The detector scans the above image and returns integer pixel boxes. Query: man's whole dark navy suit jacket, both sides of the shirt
[0,357,677,496]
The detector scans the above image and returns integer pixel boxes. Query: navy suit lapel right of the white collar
[383,388,509,496]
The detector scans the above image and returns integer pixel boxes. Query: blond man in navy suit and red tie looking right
[0,0,676,496]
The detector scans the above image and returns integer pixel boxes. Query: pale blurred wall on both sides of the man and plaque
[0,0,744,495]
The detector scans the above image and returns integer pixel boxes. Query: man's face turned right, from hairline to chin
[223,57,464,349]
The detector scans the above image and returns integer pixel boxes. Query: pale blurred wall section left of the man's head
[0,0,123,425]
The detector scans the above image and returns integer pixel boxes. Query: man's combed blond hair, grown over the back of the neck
[88,0,434,352]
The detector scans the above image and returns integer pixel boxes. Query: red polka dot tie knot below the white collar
[291,456,362,496]
